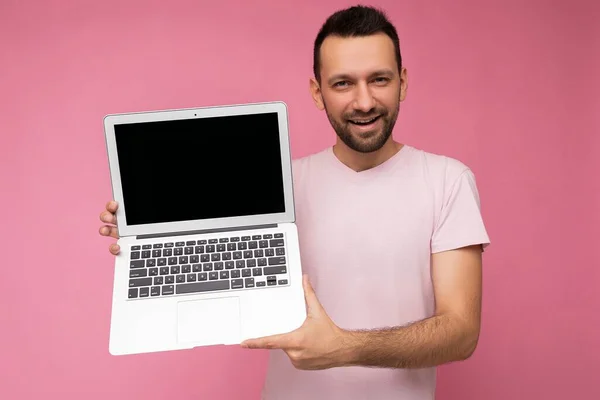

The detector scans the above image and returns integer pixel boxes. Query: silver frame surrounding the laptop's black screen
[104,101,296,237]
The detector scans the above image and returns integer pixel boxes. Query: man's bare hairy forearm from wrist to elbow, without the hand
[341,315,478,368]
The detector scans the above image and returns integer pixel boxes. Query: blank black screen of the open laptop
[115,113,285,225]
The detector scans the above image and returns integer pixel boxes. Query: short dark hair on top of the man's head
[313,5,402,83]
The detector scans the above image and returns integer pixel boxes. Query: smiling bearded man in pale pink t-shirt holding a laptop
[100,7,489,400]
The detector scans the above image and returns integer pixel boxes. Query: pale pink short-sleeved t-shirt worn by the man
[263,145,489,400]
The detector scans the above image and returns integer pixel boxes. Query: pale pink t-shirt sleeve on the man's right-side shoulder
[431,168,490,253]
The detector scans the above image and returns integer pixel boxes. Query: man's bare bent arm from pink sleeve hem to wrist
[338,245,482,368]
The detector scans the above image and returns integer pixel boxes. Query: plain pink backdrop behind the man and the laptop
[0,0,600,400]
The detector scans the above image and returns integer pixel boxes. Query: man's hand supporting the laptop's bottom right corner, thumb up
[241,275,348,370]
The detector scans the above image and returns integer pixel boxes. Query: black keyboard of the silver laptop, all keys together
[129,233,288,299]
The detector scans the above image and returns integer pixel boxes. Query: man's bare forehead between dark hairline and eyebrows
[320,33,396,75]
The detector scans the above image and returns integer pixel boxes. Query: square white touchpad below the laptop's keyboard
[177,297,240,346]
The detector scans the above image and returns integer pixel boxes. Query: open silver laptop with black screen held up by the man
[104,102,306,355]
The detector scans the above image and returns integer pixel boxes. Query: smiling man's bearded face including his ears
[311,34,406,153]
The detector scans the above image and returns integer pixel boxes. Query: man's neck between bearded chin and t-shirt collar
[333,136,404,172]
